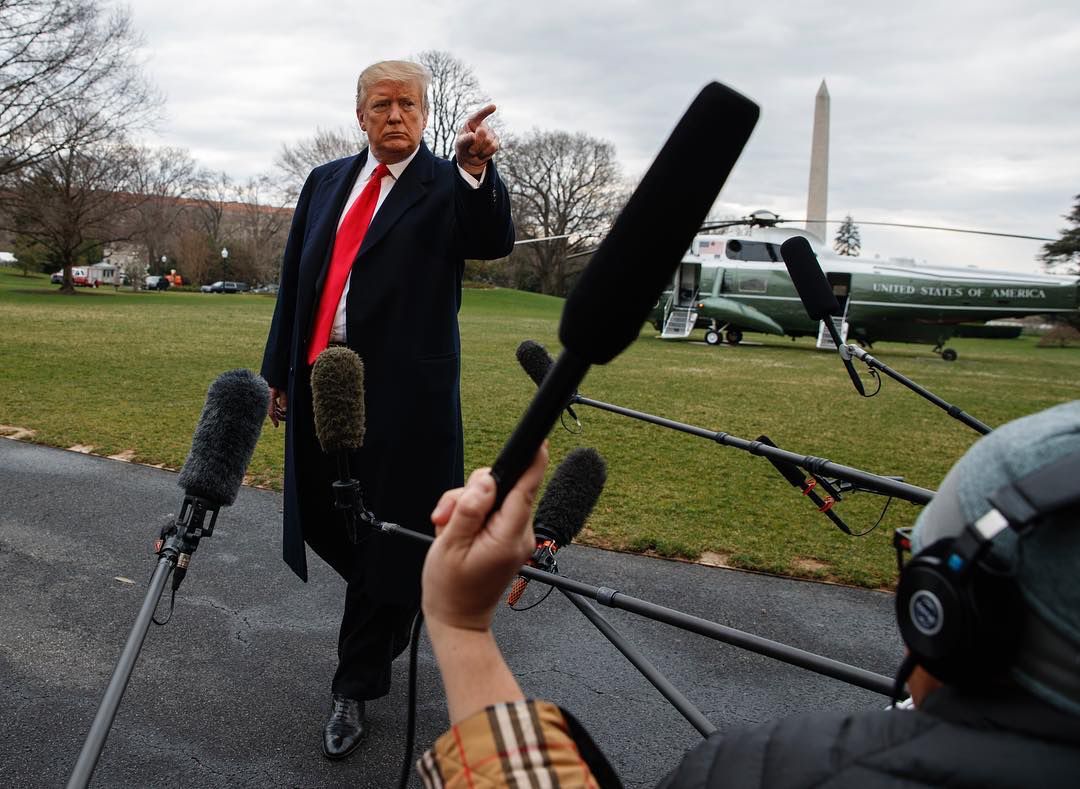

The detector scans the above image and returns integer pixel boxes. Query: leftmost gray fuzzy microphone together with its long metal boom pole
[67,370,270,789]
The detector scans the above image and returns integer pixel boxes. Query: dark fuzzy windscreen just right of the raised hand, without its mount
[532,447,607,546]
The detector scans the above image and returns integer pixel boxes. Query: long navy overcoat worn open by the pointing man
[261,144,514,602]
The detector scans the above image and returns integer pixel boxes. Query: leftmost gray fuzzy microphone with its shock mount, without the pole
[167,369,270,591]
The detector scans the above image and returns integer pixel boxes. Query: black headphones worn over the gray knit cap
[896,452,1080,688]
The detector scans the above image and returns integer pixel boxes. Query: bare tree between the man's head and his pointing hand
[415,50,490,159]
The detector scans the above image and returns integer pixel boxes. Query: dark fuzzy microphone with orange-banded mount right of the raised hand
[507,447,607,608]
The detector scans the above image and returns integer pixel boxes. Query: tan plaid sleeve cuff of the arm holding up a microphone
[417,700,598,789]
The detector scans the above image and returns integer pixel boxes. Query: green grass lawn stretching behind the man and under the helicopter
[0,271,1080,587]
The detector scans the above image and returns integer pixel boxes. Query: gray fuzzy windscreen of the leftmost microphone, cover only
[177,369,270,504]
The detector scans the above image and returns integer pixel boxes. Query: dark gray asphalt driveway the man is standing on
[0,439,901,787]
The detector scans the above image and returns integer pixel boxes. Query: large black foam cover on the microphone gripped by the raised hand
[558,82,759,365]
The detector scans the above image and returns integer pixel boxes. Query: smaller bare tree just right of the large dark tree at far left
[131,148,199,274]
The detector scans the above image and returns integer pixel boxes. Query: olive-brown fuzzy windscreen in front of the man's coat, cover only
[311,345,364,453]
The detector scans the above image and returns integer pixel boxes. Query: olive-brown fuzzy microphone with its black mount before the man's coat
[311,345,367,544]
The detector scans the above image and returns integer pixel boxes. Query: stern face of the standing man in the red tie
[356,80,428,164]
